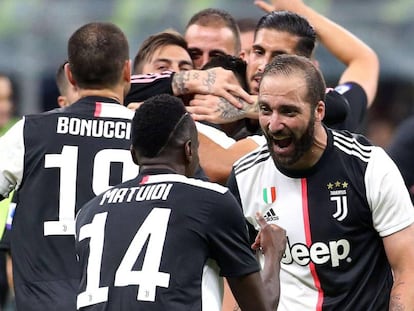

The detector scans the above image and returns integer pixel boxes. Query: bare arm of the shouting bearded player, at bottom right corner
[383,224,414,311]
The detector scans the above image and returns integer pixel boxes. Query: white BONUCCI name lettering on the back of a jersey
[56,117,131,139]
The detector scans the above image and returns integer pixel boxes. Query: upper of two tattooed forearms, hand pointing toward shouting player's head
[172,67,253,108]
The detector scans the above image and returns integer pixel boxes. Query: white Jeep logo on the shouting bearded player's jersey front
[282,238,352,267]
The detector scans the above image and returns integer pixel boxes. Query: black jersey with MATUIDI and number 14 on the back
[76,170,260,311]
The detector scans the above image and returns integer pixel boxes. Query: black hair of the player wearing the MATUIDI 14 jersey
[131,94,195,158]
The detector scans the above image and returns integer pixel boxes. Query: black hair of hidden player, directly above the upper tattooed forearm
[202,55,248,90]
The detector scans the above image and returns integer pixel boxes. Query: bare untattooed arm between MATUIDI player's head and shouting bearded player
[198,133,258,185]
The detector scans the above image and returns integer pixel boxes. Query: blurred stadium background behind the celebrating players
[0,0,414,144]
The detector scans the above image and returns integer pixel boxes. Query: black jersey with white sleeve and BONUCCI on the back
[0,97,138,311]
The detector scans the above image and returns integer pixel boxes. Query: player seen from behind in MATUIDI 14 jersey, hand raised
[76,94,286,311]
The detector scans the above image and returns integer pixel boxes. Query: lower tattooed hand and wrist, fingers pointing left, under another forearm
[187,95,259,124]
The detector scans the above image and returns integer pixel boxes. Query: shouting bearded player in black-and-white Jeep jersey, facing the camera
[228,55,414,310]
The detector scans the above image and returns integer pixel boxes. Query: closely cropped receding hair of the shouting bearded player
[262,54,326,108]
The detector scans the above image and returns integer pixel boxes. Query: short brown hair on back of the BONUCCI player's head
[68,22,129,89]
